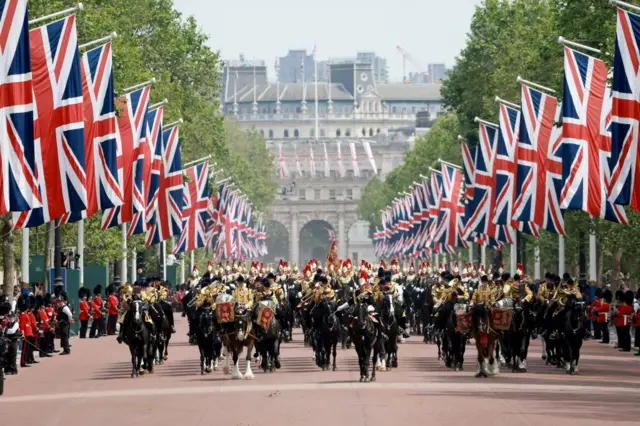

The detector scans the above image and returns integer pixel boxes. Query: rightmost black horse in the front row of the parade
[558,294,588,375]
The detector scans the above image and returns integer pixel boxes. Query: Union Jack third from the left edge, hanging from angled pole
[60,43,122,225]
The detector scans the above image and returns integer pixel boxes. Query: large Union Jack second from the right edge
[560,48,628,224]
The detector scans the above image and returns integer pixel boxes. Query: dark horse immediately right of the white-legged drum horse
[254,301,281,373]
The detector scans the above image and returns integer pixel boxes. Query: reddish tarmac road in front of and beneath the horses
[0,320,640,426]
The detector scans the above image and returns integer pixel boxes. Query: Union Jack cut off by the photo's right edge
[609,9,640,211]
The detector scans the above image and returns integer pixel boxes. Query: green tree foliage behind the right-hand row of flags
[358,0,640,286]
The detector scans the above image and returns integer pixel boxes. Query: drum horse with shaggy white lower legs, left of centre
[216,302,255,380]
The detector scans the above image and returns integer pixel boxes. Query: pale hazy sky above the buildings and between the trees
[174,0,480,81]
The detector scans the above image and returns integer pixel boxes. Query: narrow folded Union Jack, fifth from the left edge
[129,107,164,236]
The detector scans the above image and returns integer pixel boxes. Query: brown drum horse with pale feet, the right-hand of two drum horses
[471,302,504,378]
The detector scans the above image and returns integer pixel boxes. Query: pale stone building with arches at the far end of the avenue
[221,56,442,264]
